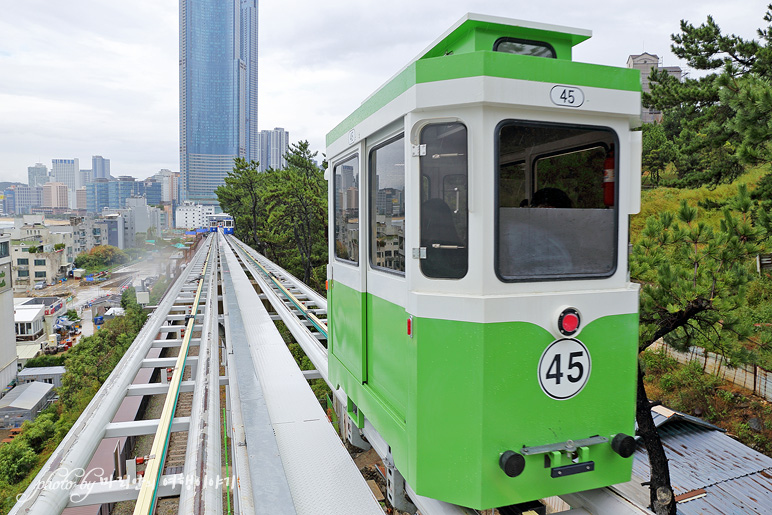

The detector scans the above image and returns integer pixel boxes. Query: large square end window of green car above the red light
[496,121,617,281]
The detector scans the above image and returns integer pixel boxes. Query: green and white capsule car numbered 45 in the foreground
[327,14,641,509]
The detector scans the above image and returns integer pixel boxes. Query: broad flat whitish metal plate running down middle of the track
[224,236,383,515]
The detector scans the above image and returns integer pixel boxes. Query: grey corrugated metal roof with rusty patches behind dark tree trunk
[613,407,772,515]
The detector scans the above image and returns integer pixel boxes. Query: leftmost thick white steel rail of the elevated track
[9,241,210,515]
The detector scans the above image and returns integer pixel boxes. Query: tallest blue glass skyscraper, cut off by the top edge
[180,0,259,203]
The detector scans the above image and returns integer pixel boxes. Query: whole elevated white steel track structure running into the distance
[10,233,645,515]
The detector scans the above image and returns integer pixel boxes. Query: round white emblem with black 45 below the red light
[539,338,592,401]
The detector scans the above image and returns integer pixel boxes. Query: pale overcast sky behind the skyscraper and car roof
[0,0,768,183]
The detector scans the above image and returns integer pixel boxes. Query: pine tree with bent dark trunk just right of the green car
[630,187,769,514]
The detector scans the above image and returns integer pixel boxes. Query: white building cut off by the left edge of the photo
[0,234,16,387]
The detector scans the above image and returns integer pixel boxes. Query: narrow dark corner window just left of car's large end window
[420,122,469,279]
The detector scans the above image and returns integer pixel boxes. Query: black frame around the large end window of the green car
[493,118,621,283]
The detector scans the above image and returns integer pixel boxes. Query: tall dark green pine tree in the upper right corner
[643,5,772,186]
